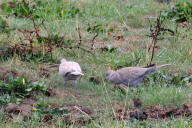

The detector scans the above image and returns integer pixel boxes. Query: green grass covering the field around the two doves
[0,0,192,128]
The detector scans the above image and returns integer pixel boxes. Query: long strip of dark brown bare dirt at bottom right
[115,104,192,120]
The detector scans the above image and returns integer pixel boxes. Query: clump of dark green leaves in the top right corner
[163,1,192,23]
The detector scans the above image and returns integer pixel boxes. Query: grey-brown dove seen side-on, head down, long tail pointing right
[105,64,170,86]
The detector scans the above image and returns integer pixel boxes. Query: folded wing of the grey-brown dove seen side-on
[117,67,149,86]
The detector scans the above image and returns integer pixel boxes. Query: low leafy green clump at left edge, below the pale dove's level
[0,75,47,104]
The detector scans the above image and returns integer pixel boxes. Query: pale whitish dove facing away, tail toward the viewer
[59,59,84,87]
